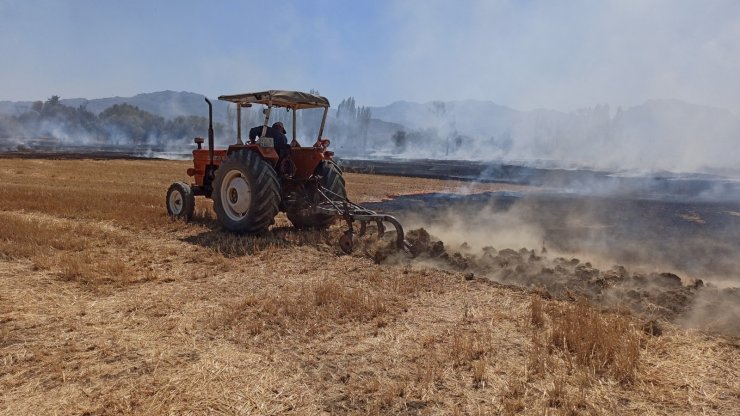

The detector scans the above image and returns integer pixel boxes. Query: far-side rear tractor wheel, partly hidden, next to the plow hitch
[285,160,347,228]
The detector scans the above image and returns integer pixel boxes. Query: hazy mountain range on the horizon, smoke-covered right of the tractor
[0,91,740,171]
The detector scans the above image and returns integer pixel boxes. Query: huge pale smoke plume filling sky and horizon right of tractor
[320,1,740,173]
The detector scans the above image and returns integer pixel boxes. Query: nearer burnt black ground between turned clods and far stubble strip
[369,192,740,282]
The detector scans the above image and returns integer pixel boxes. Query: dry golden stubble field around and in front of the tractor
[0,158,740,415]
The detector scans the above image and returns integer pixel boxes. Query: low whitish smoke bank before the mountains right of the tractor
[358,100,740,173]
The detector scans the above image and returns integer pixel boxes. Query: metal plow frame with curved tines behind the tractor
[316,186,412,254]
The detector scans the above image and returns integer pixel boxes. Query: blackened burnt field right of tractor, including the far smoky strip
[352,161,740,285]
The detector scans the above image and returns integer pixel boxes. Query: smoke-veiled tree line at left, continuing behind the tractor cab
[0,91,382,154]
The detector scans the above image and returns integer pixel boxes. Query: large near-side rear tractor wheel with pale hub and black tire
[212,150,280,233]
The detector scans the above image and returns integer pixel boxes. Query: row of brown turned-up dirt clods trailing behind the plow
[375,228,740,334]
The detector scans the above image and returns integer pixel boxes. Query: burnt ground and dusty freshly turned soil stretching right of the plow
[362,192,740,336]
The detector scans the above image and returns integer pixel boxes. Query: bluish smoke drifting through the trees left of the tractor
[0,92,235,158]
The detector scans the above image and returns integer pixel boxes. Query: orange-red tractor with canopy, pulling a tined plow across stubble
[166,90,410,253]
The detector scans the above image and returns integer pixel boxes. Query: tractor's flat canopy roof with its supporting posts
[218,90,329,145]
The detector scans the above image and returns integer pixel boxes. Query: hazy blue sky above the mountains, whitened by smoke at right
[0,0,740,114]
